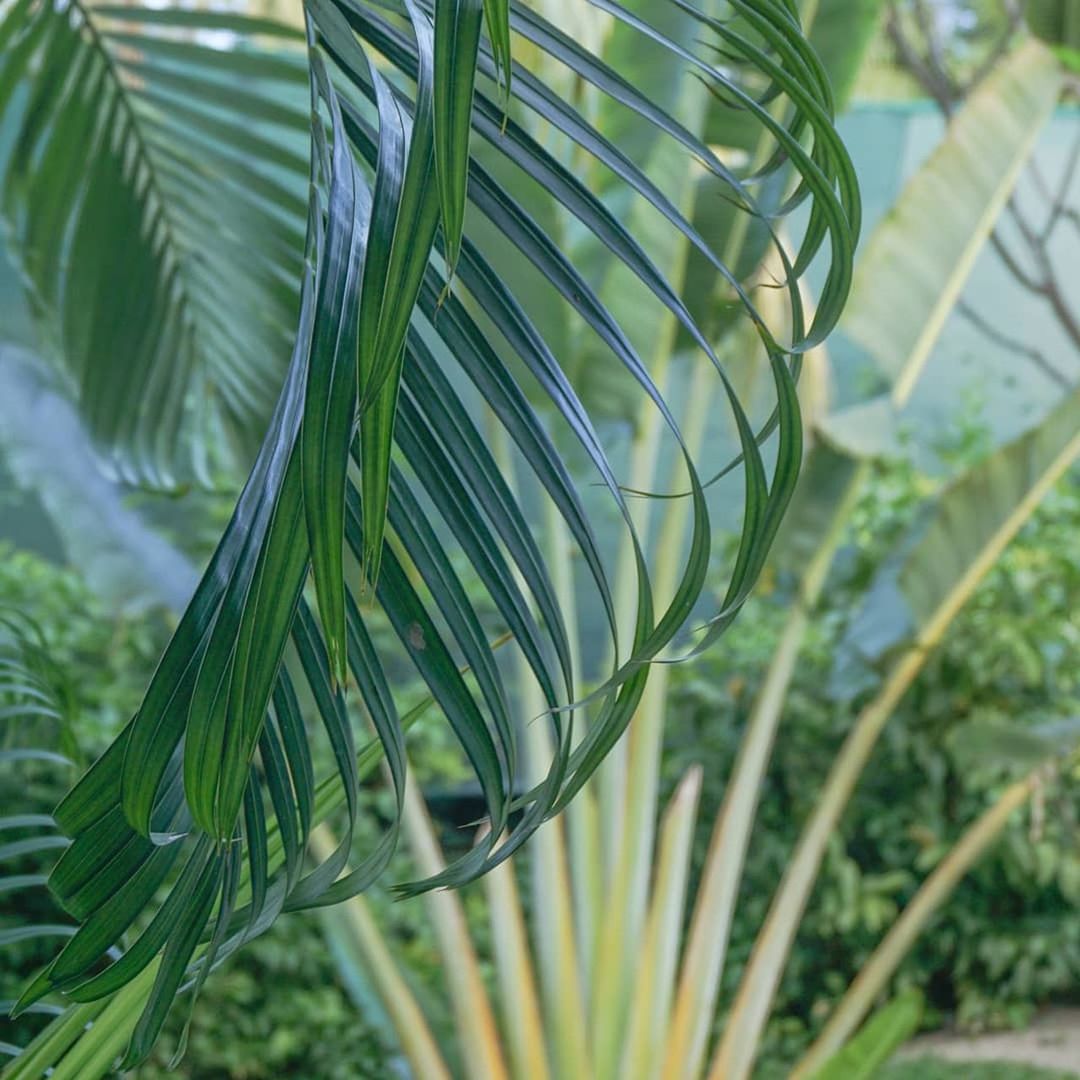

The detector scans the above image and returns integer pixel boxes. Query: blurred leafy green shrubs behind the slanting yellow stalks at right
[665,449,1080,1058]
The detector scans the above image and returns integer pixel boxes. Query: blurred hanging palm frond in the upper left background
[0,0,309,486]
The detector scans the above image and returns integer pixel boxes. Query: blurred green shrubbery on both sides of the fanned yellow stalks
[10,430,1080,1080]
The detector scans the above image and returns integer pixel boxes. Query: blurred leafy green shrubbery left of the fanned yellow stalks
[0,545,455,1080]
